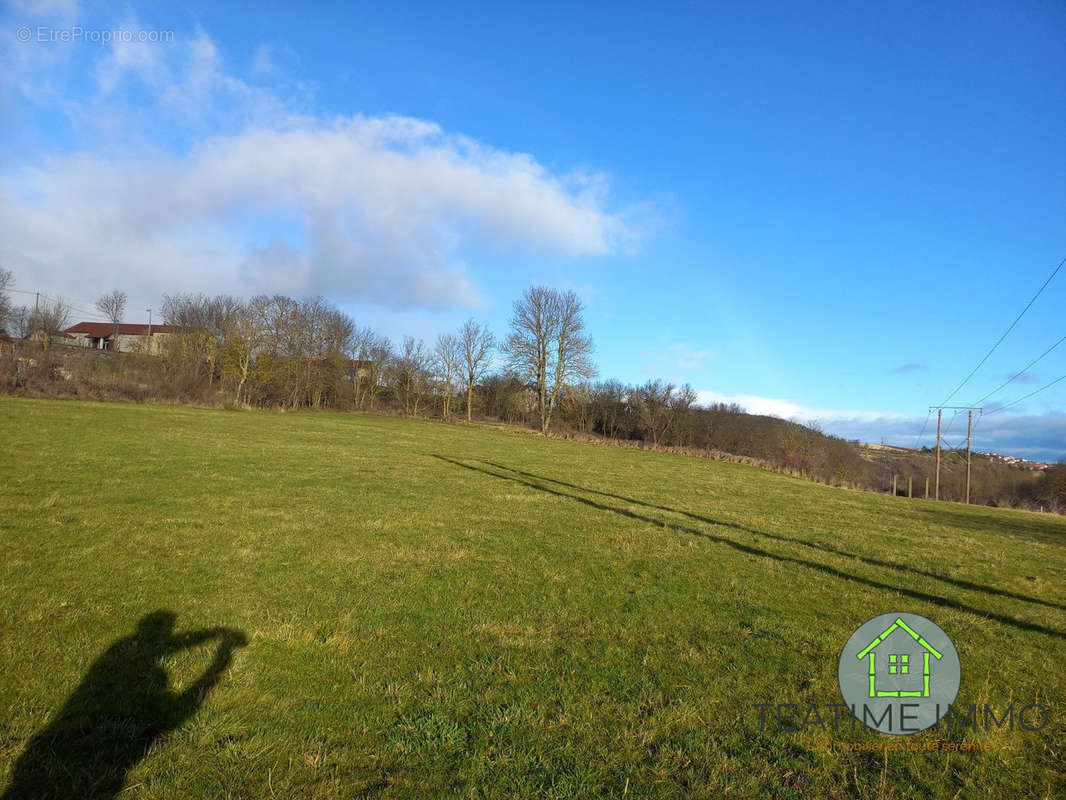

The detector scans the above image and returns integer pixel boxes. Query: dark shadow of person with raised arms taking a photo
[2,611,246,800]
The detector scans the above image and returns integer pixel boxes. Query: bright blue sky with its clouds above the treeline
[6,1,1066,459]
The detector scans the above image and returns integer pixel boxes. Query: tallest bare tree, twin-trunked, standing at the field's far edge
[503,286,596,433]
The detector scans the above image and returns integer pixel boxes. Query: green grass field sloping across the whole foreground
[0,398,1066,799]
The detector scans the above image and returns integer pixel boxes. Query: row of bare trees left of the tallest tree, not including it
[153,294,503,418]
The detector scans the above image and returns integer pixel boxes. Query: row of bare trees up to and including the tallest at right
[144,287,595,432]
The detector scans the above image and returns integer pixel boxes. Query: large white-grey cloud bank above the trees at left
[0,21,640,308]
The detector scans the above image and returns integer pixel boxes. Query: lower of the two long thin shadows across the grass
[433,453,1066,640]
